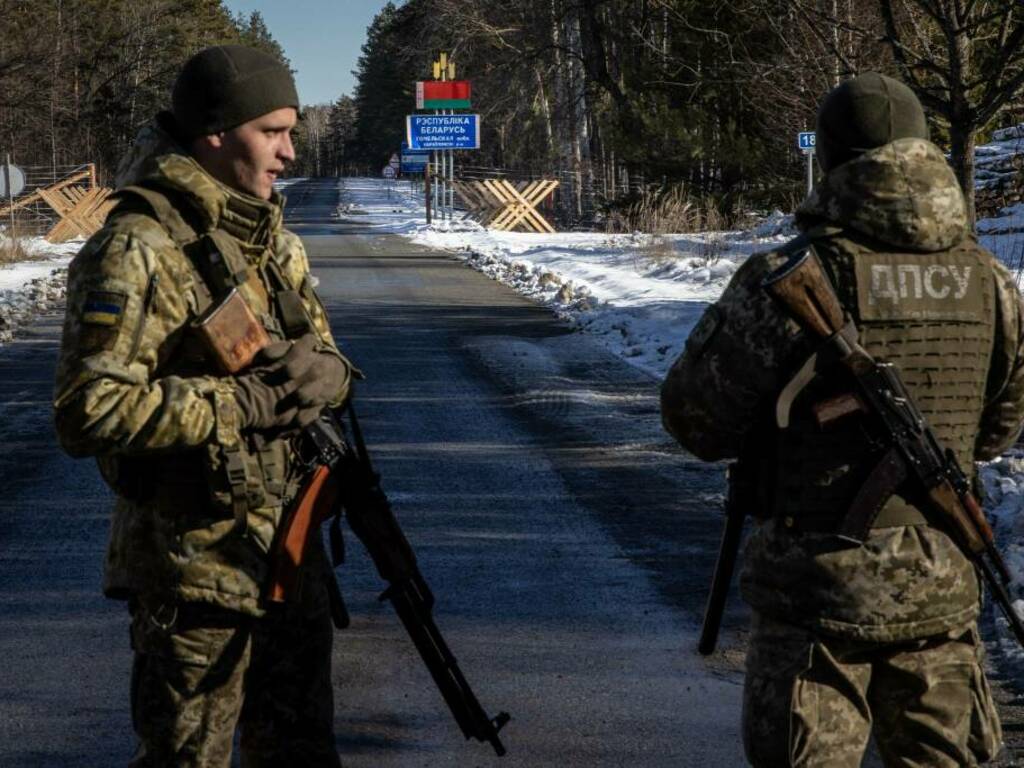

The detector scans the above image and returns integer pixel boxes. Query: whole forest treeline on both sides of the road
[0,0,1024,226]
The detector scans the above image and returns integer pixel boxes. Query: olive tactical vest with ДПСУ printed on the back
[761,234,995,532]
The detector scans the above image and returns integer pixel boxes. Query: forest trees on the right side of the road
[304,0,1024,228]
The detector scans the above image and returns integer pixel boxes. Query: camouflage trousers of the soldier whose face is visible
[130,604,341,768]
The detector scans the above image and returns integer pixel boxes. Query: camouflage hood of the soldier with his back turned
[797,138,967,252]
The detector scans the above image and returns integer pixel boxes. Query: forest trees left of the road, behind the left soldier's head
[0,0,287,181]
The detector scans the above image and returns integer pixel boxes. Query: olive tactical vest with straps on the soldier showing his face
[99,186,312,530]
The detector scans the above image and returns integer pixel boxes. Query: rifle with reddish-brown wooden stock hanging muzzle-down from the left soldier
[267,398,510,757]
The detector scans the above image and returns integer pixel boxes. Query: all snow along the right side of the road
[346,125,1024,660]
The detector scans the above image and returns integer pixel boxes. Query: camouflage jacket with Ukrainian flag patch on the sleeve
[54,123,340,615]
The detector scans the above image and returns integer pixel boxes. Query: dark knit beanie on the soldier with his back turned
[815,72,928,173]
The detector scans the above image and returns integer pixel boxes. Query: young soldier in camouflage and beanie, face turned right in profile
[54,46,351,768]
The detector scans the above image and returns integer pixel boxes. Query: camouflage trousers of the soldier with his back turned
[743,614,1001,768]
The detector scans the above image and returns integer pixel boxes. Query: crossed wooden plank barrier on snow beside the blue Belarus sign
[455,179,558,232]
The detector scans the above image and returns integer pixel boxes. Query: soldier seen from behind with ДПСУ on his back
[662,74,1024,768]
